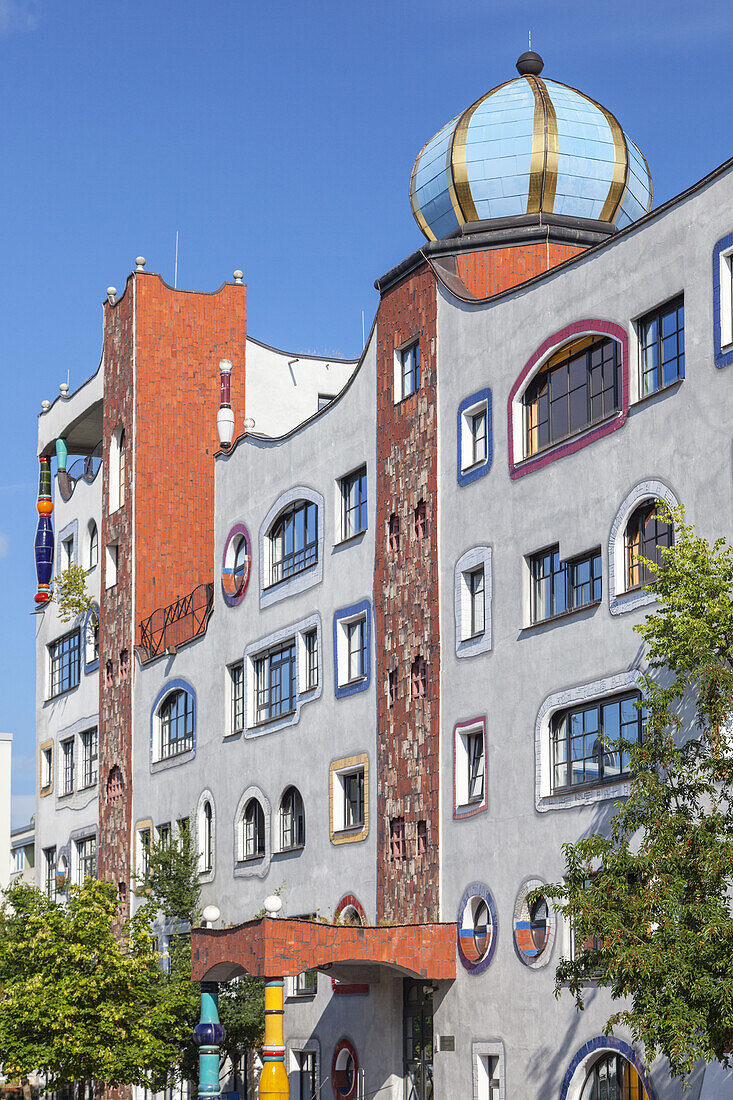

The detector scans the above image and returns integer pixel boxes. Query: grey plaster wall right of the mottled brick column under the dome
[436,160,733,1098]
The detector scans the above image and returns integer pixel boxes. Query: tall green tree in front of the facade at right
[543,504,733,1076]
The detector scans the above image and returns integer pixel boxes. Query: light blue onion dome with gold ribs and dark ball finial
[409,52,653,241]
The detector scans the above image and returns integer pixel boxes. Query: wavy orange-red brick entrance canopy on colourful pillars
[190,916,456,981]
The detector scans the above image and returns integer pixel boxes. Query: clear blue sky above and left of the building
[0,0,733,824]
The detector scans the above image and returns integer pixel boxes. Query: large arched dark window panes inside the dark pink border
[523,339,621,455]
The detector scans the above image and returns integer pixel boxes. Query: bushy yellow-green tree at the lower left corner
[0,879,188,1095]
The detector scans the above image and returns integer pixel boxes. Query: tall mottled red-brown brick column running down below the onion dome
[374,265,440,922]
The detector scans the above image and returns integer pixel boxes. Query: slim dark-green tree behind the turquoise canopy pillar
[140,828,264,1081]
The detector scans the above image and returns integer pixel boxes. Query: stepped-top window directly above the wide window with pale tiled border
[529,545,602,623]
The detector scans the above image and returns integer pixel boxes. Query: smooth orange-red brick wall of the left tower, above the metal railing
[134,274,247,624]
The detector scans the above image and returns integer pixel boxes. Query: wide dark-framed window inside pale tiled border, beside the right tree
[551,692,644,792]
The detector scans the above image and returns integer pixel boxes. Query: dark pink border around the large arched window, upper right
[506,317,628,479]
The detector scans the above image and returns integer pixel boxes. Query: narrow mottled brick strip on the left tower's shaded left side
[98,276,134,916]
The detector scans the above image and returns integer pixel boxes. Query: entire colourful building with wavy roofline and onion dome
[36,54,733,1100]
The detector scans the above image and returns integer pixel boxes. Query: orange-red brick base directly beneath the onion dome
[456,241,584,298]
